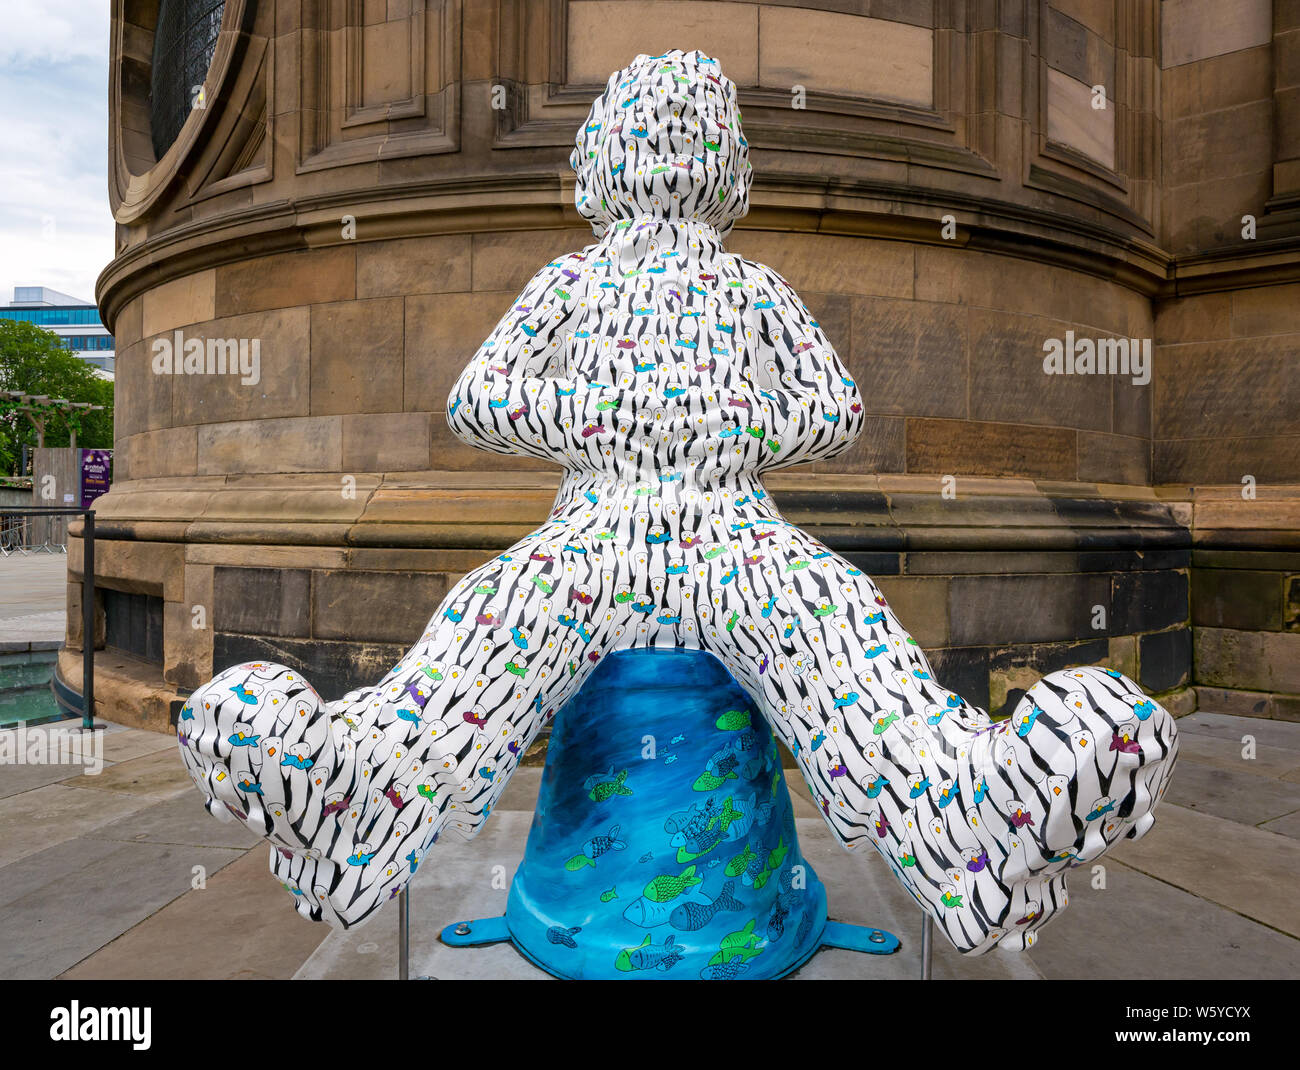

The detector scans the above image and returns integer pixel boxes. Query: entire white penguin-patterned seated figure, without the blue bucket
[179,51,1177,953]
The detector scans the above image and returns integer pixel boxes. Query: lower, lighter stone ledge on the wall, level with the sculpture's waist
[81,472,1191,553]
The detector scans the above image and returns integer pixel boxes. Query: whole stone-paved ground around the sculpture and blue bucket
[0,714,1300,979]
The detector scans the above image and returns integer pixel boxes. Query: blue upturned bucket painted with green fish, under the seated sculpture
[506,649,827,979]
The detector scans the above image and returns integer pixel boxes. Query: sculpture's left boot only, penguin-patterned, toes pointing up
[178,662,454,928]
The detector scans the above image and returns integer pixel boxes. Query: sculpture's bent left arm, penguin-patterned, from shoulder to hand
[447,257,625,464]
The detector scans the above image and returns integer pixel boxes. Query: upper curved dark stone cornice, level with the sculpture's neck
[96,173,1300,330]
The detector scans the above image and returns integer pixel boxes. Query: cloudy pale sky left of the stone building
[0,0,113,304]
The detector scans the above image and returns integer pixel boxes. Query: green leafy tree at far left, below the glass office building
[0,320,113,473]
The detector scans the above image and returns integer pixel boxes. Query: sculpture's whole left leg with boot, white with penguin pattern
[181,529,621,927]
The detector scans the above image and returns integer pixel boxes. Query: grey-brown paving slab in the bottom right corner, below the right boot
[1028,858,1300,980]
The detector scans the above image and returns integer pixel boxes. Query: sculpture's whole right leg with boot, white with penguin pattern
[703,529,1177,952]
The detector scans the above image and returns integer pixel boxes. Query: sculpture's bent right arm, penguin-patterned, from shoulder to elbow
[745,261,863,469]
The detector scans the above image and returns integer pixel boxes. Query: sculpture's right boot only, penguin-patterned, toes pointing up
[848,667,1178,953]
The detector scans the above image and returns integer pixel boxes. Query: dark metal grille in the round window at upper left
[150,0,226,160]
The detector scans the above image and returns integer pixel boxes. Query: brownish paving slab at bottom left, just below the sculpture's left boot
[62,847,332,980]
